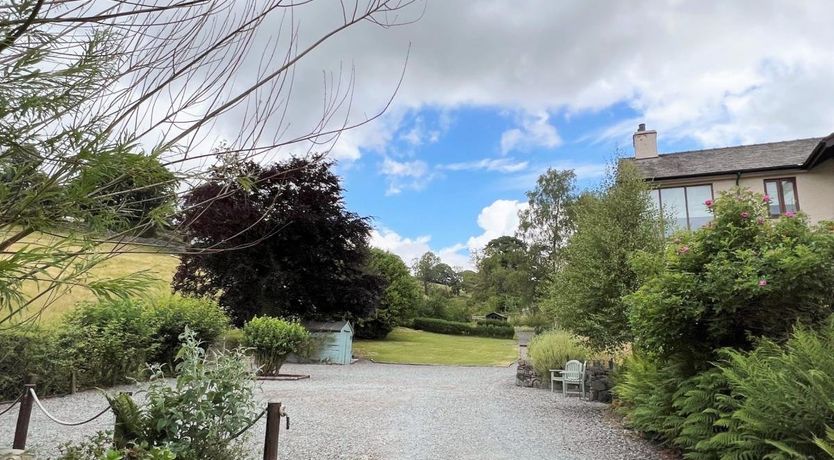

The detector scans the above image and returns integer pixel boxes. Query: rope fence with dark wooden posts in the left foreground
[0,383,290,460]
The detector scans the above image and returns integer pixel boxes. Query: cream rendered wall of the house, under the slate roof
[653,160,834,223]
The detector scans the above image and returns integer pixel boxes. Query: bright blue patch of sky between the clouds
[338,104,698,267]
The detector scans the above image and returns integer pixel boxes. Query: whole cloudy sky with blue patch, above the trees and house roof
[210,0,834,268]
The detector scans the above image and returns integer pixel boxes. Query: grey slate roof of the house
[629,135,834,179]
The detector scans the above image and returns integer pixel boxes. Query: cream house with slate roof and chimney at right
[629,124,834,230]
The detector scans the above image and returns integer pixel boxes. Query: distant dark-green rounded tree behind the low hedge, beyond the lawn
[473,236,536,312]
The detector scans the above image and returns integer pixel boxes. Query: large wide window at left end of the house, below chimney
[652,185,712,233]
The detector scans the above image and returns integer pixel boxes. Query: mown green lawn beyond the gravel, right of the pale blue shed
[353,327,518,366]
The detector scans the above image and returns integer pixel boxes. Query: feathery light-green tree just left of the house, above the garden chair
[542,161,663,349]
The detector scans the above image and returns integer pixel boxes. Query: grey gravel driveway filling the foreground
[0,362,664,460]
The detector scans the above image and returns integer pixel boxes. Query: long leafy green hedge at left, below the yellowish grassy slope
[0,296,229,401]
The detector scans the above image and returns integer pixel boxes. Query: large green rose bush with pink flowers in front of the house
[626,189,834,368]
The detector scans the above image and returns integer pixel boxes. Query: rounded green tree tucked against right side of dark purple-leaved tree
[356,248,423,339]
